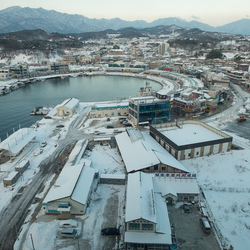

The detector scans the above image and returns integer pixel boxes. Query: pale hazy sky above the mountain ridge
[0,0,250,26]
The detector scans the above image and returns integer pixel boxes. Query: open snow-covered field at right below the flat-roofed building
[182,149,250,250]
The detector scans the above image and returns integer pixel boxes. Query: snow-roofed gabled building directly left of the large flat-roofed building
[115,129,189,173]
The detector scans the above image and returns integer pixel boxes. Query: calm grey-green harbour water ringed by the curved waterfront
[0,76,161,140]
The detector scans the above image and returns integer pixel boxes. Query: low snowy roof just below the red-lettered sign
[151,174,199,196]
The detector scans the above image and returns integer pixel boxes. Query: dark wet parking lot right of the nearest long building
[168,206,220,250]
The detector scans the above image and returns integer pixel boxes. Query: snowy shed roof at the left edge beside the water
[0,128,37,154]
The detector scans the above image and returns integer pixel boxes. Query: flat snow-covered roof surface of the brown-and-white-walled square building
[159,124,223,146]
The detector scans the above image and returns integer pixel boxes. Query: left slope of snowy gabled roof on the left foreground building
[43,164,83,203]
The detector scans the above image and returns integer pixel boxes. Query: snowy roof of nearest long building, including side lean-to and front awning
[125,172,172,244]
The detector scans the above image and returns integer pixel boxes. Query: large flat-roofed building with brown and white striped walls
[150,121,233,160]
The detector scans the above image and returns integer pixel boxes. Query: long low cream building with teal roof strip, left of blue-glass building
[89,101,128,118]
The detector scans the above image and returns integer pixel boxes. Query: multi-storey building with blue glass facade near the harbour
[129,96,170,125]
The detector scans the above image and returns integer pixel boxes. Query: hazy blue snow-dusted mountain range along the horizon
[0,6,250,35]
